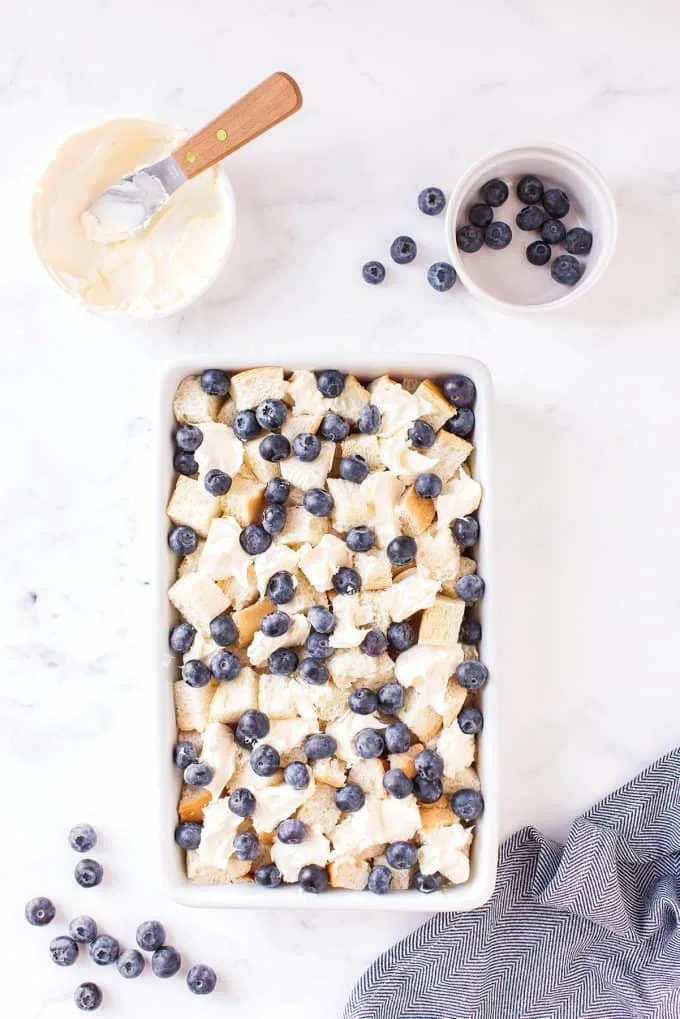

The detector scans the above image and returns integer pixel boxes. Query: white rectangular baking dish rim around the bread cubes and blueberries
[158,354,499,912]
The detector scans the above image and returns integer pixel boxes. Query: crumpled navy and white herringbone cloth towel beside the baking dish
[345,748,680,1019]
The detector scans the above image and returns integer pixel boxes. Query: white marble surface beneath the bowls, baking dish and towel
[5,0,680,1019]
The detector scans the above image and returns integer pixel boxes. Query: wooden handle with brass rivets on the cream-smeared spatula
[172,70,302,177]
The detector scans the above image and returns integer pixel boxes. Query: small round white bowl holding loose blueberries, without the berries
[446,145,617,312]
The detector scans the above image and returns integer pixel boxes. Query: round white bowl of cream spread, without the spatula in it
[31,117,236,319]
